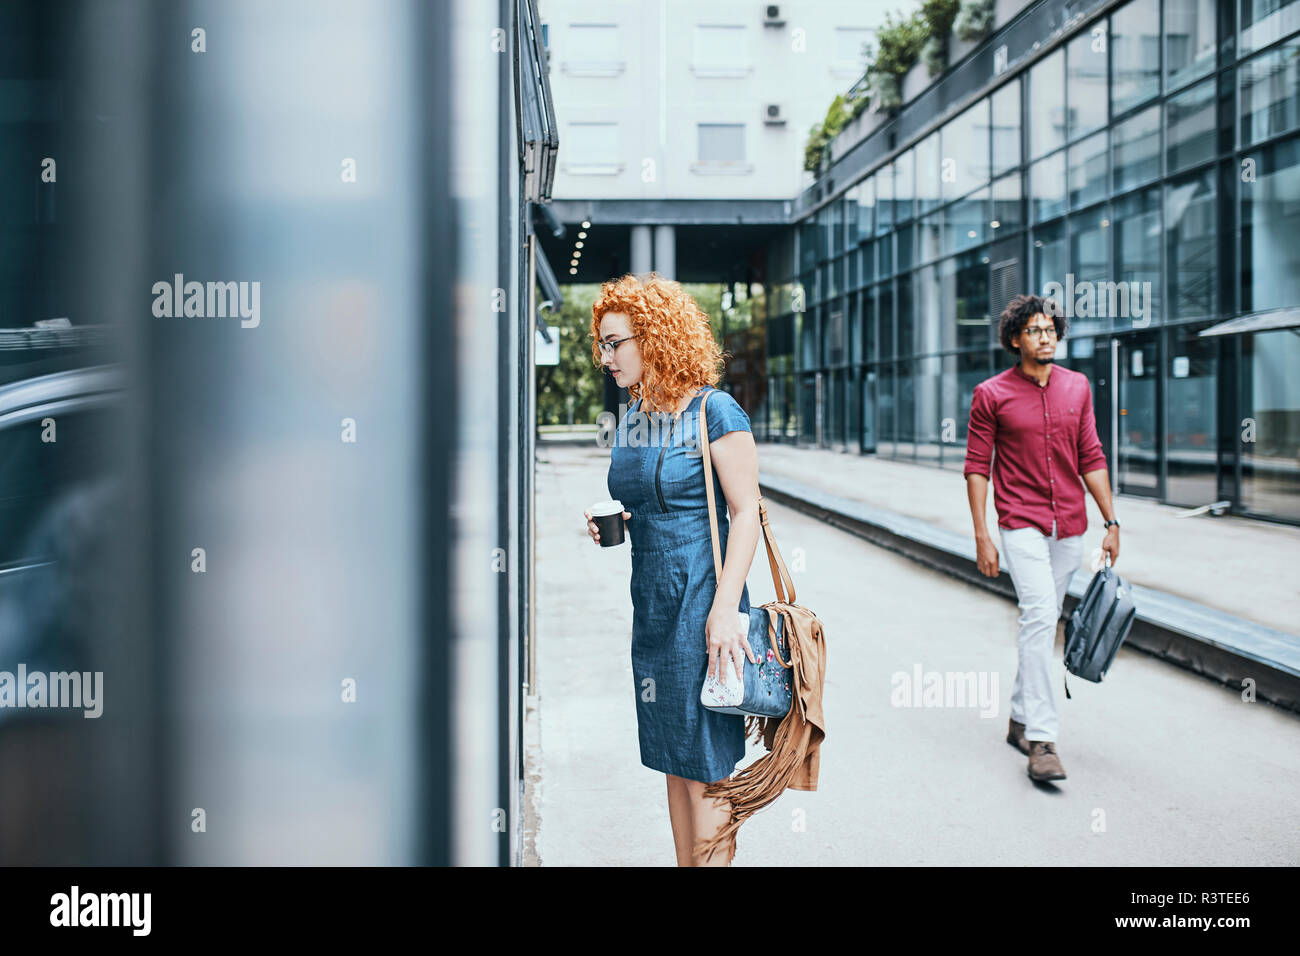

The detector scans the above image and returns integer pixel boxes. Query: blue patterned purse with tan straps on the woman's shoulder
[699,393,794,718]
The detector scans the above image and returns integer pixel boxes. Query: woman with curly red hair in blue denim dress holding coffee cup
[586,273,759,866]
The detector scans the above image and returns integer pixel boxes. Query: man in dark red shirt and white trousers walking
[965,295,1119,780]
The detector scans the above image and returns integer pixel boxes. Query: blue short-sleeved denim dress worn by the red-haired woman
[607,389,750,783]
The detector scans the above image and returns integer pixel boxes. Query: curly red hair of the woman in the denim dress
[592,272,724,411]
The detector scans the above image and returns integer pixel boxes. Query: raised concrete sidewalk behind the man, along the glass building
[758,442,1300,643]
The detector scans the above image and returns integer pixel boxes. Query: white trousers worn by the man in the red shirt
[998,524,1083,740]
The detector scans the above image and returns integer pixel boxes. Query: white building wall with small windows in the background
[540,0,918,199]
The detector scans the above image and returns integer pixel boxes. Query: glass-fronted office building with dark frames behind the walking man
[754,0,1300,523]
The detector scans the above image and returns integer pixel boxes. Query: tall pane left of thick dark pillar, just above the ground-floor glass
[1157,170,1218,319]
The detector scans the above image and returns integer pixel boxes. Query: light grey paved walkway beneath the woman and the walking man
[527,445,1300,866]
